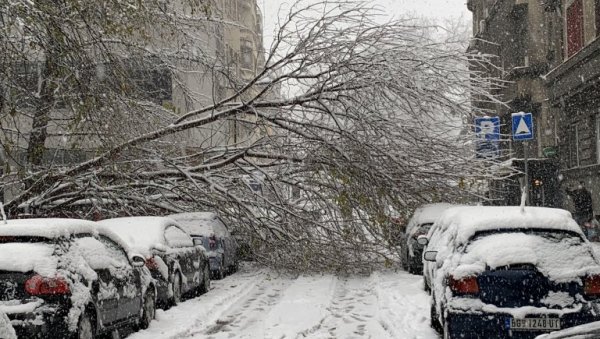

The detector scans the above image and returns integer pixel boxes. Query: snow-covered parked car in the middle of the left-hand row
[98,217,210,308]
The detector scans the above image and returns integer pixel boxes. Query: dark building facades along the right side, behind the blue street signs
[467,0,600,211]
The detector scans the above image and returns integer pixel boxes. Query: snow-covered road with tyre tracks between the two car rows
[128,267,439,339]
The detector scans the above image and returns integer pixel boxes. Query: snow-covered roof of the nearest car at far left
[0,218,96,239]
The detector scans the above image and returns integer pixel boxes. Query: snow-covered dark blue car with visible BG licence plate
[423,206,600,338]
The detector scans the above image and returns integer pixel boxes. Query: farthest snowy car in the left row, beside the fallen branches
[170,212,239,279]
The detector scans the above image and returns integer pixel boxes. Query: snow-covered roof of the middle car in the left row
[98,217,180,254]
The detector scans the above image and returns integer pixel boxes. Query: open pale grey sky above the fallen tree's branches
[257,0,471,46]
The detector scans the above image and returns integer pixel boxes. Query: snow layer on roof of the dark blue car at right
[436,206,583,244]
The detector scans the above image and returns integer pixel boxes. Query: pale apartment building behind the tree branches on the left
[0,0,265,202]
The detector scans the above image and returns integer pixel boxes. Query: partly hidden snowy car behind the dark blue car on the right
[400,203,453,274]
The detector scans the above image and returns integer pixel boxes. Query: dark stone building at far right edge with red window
[545,0,600,202]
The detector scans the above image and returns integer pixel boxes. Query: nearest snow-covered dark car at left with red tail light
[0,219,156,338]
